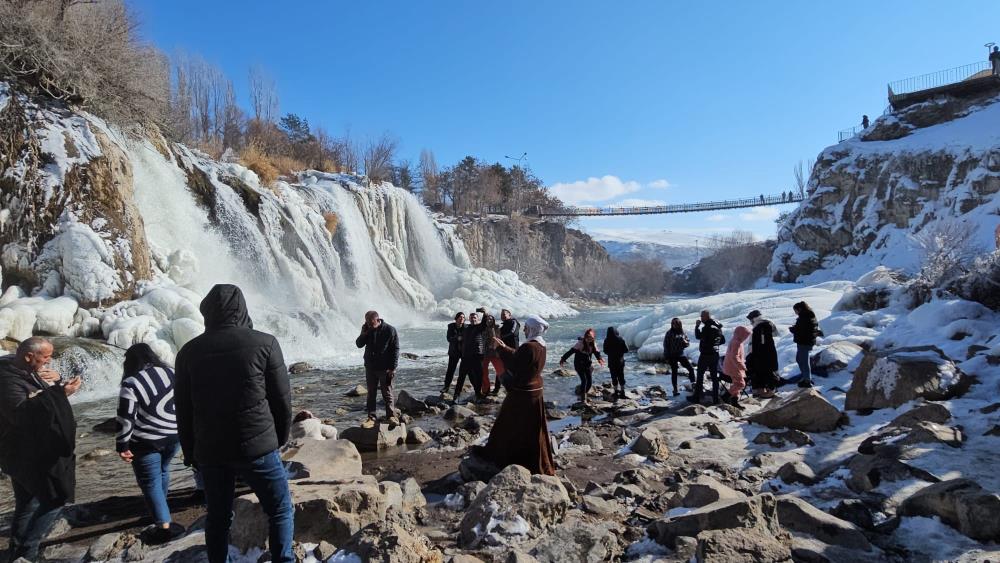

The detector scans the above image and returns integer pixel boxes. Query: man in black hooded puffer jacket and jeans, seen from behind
[174,285,295,563]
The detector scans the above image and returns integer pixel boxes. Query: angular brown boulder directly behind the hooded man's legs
[231,475,389,552]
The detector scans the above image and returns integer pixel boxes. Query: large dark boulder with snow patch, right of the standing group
[844,346,972,410]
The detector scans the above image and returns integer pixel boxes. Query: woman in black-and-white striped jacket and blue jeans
[115,344,183,544]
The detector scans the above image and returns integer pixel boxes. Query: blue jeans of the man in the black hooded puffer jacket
[200,450,295,563]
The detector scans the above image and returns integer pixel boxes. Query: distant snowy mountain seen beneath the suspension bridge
[590,229,706,268]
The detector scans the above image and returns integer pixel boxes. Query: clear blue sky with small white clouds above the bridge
[131,0,1000,245]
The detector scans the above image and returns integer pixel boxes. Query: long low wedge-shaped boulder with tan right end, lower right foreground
[646,494,782,549]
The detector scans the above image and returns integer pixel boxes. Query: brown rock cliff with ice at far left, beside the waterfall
[0,83,152,306]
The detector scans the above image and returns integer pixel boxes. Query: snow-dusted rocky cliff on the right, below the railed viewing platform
[769,97,1000,281]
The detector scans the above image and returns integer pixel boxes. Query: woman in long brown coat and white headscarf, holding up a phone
[473,315,556,475]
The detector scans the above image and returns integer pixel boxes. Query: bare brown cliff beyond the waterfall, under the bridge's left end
[455,216,609,294]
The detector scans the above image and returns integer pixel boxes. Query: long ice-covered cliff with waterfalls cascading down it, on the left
[0,84,574,398]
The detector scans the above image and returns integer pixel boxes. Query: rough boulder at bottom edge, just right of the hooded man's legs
[333,519,444,563]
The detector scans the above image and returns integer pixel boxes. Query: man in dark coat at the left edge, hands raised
[0,337,81,561]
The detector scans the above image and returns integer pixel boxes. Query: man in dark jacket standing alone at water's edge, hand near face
[354,311,399,428]
